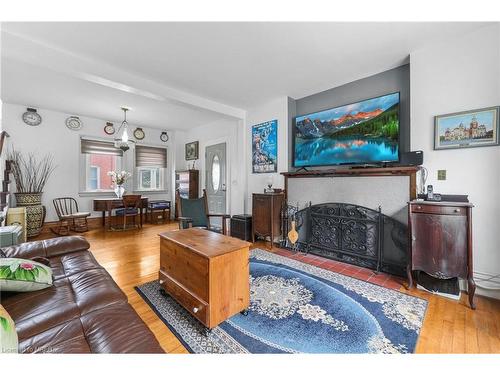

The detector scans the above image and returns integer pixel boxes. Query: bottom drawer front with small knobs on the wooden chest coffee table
[159,271,209,325]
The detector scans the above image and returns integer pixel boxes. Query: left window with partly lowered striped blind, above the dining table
[80,138,123,193]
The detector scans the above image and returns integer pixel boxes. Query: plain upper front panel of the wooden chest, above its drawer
[160,238,209,301]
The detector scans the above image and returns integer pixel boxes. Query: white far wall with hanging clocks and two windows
[3,103,175,221]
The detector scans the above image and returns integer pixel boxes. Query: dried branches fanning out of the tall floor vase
[7,149,56,193]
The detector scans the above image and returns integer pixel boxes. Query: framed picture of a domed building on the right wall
[434,107,500,150]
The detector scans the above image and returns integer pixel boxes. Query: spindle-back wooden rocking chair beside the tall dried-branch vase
[51,197,90,236]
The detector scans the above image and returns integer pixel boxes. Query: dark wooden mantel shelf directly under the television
[281,167,420,178]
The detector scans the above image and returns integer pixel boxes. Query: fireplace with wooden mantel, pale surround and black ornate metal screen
[282,166,420,276]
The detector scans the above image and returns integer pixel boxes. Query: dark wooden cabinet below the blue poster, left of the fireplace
[252,192,285,248]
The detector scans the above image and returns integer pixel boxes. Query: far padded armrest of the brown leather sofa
[2,236,90,259]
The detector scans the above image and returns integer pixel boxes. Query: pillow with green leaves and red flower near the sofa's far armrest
[0,258,52,292]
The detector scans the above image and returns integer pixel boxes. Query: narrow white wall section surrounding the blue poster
[245,96,289,213]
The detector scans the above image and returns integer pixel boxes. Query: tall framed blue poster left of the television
[252,120,278,173]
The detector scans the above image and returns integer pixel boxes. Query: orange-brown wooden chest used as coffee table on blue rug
[159,228,250,329]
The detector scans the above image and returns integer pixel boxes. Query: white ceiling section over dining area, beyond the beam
[2,59,223,130]
